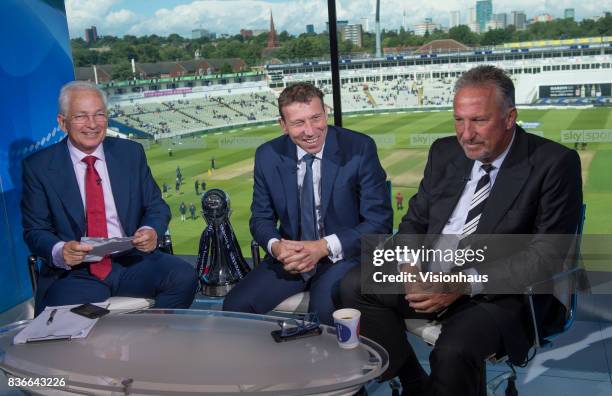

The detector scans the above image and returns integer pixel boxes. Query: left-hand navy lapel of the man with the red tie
[49,137,86,237]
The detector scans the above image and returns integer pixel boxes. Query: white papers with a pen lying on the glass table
[13,302,108,344]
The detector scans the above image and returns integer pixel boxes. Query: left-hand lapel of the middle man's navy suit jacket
[276,136,300,239]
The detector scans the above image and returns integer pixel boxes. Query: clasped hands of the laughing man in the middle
[272,239,329,274]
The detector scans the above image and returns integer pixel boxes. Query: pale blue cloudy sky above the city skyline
[66,0,612,37]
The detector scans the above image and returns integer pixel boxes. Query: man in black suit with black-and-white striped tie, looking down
[342,66,582,395]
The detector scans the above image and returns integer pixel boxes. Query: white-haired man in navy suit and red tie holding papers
[21,81,197,313]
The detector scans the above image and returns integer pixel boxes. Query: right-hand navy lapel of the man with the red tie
[102,139,132,232]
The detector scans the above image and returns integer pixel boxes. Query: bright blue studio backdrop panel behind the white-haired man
[0,0,74,313]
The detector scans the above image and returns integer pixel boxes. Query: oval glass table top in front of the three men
[0,309,388,395]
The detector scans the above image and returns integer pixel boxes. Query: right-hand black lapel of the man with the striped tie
[476,126,532,234]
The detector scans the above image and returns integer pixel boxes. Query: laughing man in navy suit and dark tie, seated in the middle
[223,83,393,324]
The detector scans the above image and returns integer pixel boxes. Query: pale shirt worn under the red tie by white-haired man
[52,138,126,269]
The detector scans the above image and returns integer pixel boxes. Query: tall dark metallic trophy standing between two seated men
[197,188,251,297]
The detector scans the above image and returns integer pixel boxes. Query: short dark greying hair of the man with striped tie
[455,65,515,109]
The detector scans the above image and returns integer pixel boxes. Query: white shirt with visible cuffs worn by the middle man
[267,144,344,263]
